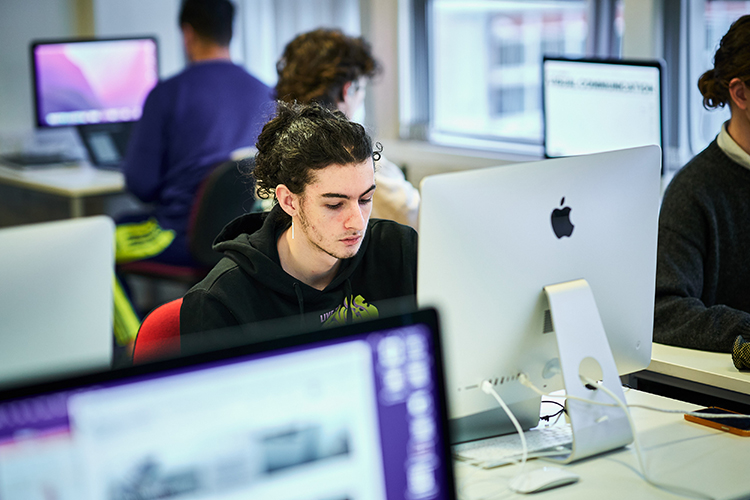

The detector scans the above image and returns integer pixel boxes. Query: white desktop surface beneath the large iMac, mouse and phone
[456,390,750,500]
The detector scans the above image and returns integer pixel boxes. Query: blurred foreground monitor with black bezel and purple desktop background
[0,310,454,500]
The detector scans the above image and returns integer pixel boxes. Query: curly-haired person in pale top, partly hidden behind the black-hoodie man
[276,29,419,229]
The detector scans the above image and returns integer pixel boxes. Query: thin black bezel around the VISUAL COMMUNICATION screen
[542,56,669,173]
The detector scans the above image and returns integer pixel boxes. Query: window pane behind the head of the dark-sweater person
[689,0,750,154]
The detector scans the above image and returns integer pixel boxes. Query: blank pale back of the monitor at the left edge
[0,216,114,388]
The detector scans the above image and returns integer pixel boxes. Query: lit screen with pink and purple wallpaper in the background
[33,39,159,127]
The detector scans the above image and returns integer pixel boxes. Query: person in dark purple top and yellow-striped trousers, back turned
[115,0,275,352]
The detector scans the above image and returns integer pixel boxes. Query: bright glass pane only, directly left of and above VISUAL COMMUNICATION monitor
[430,0,589,144]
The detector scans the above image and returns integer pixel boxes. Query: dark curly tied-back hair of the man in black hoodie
[253,101,382,199]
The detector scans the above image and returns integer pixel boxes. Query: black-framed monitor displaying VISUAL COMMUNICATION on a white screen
[542,57,666,164]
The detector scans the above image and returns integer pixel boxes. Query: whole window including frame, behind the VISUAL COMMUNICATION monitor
[402,0,621,154]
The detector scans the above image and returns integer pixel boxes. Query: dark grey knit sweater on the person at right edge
[654,140,750,352]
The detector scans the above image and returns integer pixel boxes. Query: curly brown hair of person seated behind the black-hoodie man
[276,29,381,107]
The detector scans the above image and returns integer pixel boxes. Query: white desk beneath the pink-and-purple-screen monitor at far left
[0,163,125,217]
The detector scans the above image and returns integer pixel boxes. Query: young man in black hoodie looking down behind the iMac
[180,102,417,353]
